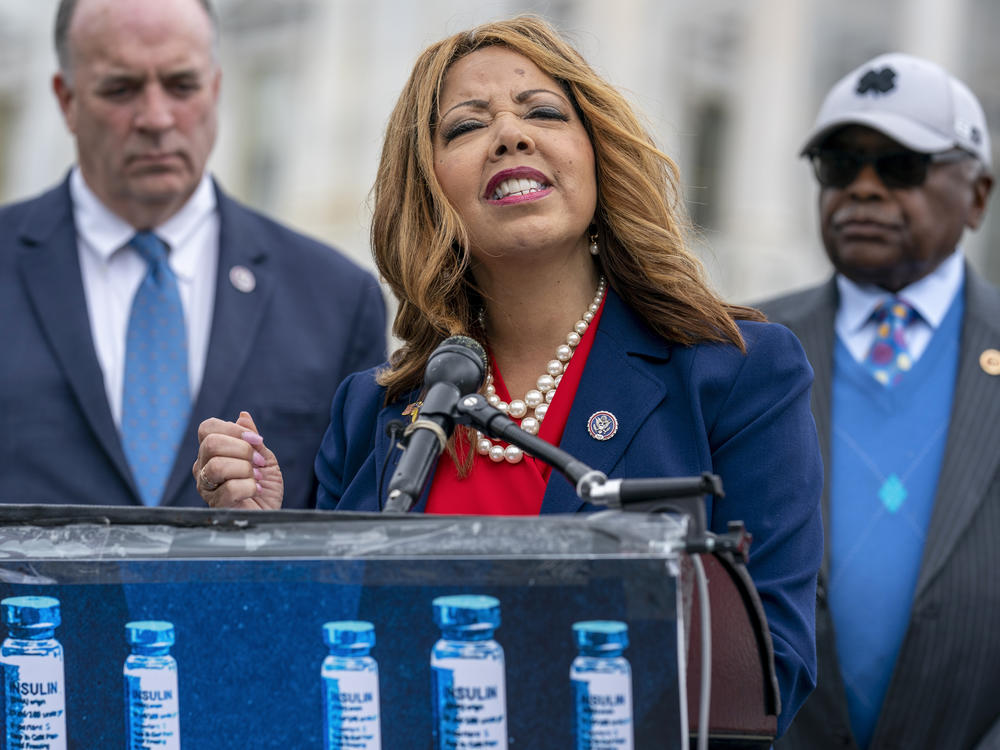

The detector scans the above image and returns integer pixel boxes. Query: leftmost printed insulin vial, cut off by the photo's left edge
[0,596,66,750]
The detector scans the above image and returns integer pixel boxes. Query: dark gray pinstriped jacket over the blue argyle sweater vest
[759,266,1000,750]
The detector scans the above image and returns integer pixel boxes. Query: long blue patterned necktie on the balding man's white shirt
[122,232,191,505]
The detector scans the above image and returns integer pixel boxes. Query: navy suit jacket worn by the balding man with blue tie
[0,180,385,507]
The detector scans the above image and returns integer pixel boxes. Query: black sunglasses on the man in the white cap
[808,148,972,188]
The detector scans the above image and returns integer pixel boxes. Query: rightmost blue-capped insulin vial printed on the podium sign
[569,620,633,750]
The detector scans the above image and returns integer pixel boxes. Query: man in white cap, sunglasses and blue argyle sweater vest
[761,54,1000,750]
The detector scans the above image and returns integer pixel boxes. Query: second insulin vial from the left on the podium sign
[122,620,181,750]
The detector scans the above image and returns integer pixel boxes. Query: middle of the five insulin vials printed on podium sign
[321,620,382,750]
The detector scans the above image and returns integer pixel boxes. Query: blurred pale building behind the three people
[0,0,1000,301]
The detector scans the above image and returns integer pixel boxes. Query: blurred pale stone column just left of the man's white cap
[715,0,828,301]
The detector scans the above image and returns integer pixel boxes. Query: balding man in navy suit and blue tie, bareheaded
[0,0,385,507]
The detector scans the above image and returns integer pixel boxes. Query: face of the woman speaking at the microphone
[434,46,597,262]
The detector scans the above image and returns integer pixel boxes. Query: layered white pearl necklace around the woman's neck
[476,276,607,464]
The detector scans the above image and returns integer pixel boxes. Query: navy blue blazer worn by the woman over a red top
[316,291,823,733]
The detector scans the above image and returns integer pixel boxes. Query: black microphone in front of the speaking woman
[385,336,486,513]
